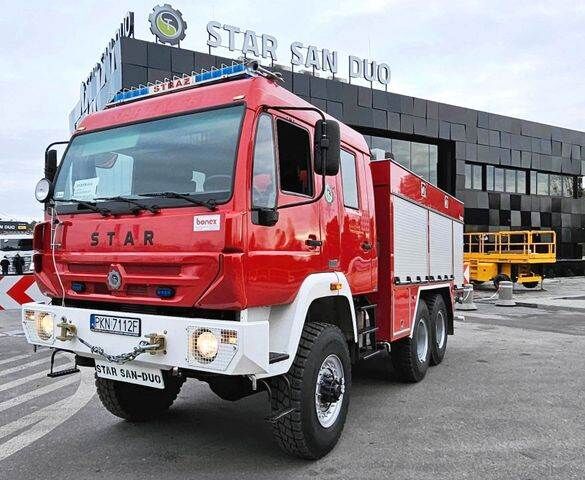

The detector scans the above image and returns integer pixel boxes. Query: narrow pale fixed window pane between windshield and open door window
[252,115,276,208]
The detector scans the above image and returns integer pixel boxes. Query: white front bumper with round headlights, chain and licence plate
[22,302,269,375]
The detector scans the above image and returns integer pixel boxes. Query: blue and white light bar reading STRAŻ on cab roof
[108,62,250,106]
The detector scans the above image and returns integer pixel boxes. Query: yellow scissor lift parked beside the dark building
[463,230,557,288]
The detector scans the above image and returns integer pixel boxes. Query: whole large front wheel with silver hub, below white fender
[271,323,351,460]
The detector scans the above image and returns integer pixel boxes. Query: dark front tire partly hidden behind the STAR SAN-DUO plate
[95,375,185,422]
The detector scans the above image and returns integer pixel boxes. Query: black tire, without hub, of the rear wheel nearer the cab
[390,299,431,383]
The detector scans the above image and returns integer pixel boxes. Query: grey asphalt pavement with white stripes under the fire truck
[0,294,585,480]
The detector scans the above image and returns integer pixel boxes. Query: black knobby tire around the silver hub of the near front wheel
[271,323,351,460]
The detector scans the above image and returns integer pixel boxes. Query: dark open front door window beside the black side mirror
[276,120,313,196]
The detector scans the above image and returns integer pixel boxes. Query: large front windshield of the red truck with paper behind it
[54,105,244,202]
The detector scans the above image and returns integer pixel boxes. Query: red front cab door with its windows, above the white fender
[246,113,323,305]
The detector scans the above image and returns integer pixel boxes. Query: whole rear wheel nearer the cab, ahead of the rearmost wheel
[390,299,431,382]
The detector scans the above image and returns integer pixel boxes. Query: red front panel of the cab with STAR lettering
[41,208,225,307]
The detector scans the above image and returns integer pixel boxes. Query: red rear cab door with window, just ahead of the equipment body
[338,146,374,295]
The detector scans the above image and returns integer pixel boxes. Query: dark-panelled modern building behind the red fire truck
[70,38,585,273]
